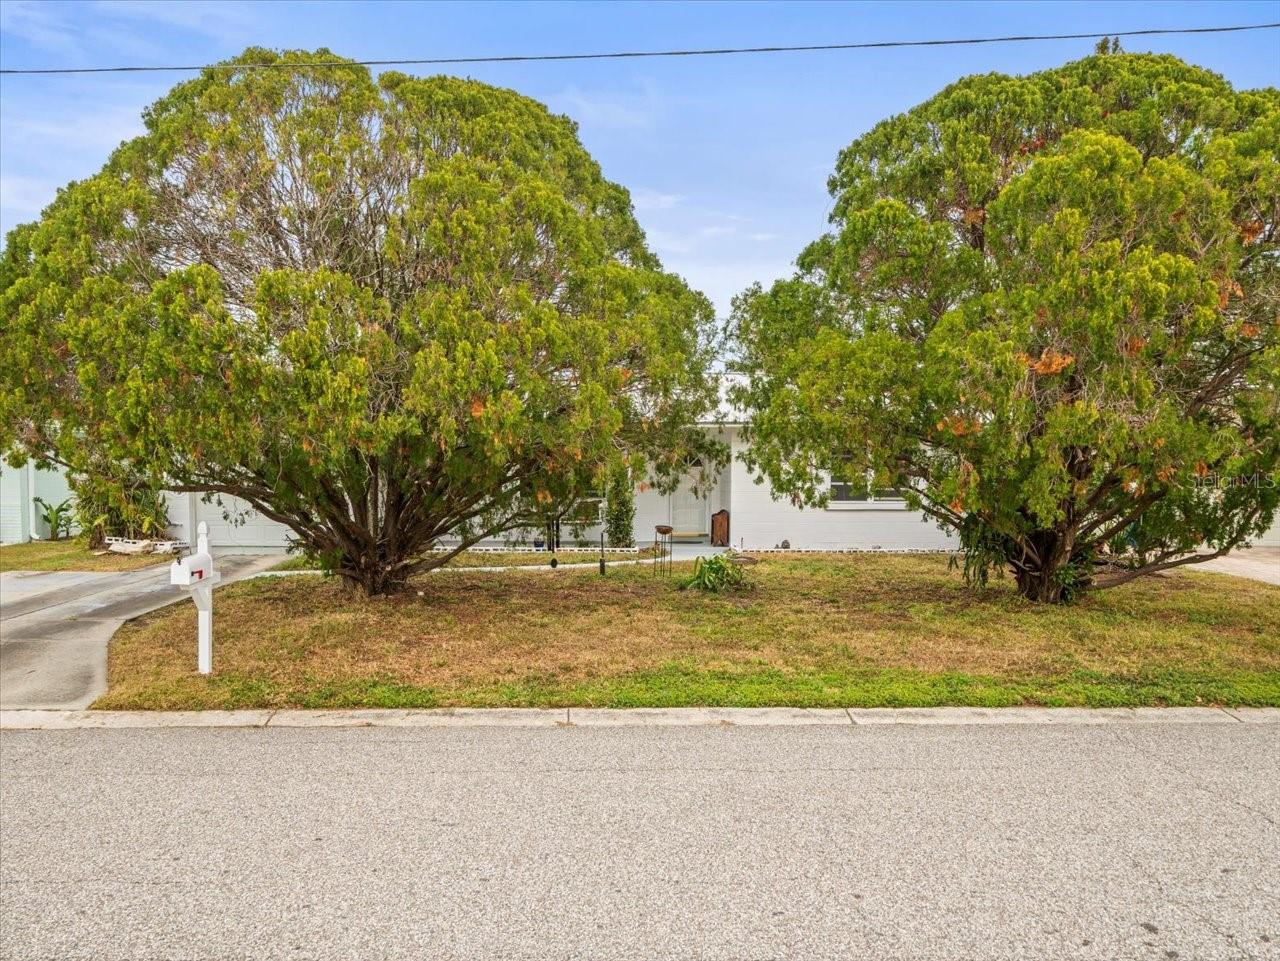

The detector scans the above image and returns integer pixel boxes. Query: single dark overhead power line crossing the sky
[0,23,1280,75]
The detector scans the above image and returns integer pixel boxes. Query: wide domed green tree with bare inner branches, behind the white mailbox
[0,49,717,592]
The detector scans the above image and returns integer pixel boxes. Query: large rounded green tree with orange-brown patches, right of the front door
[736,47,1280,601]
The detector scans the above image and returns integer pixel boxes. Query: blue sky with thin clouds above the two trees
[0,0,1280,312]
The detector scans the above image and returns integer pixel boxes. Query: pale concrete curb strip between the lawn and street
[0,708,1280,731]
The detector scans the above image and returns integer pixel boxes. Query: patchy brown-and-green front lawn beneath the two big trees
[95,554,1280,709]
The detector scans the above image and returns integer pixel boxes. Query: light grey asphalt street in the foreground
[0,722,1280,961]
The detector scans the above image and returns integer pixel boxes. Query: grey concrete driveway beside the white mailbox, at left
[0,555,282,709]
